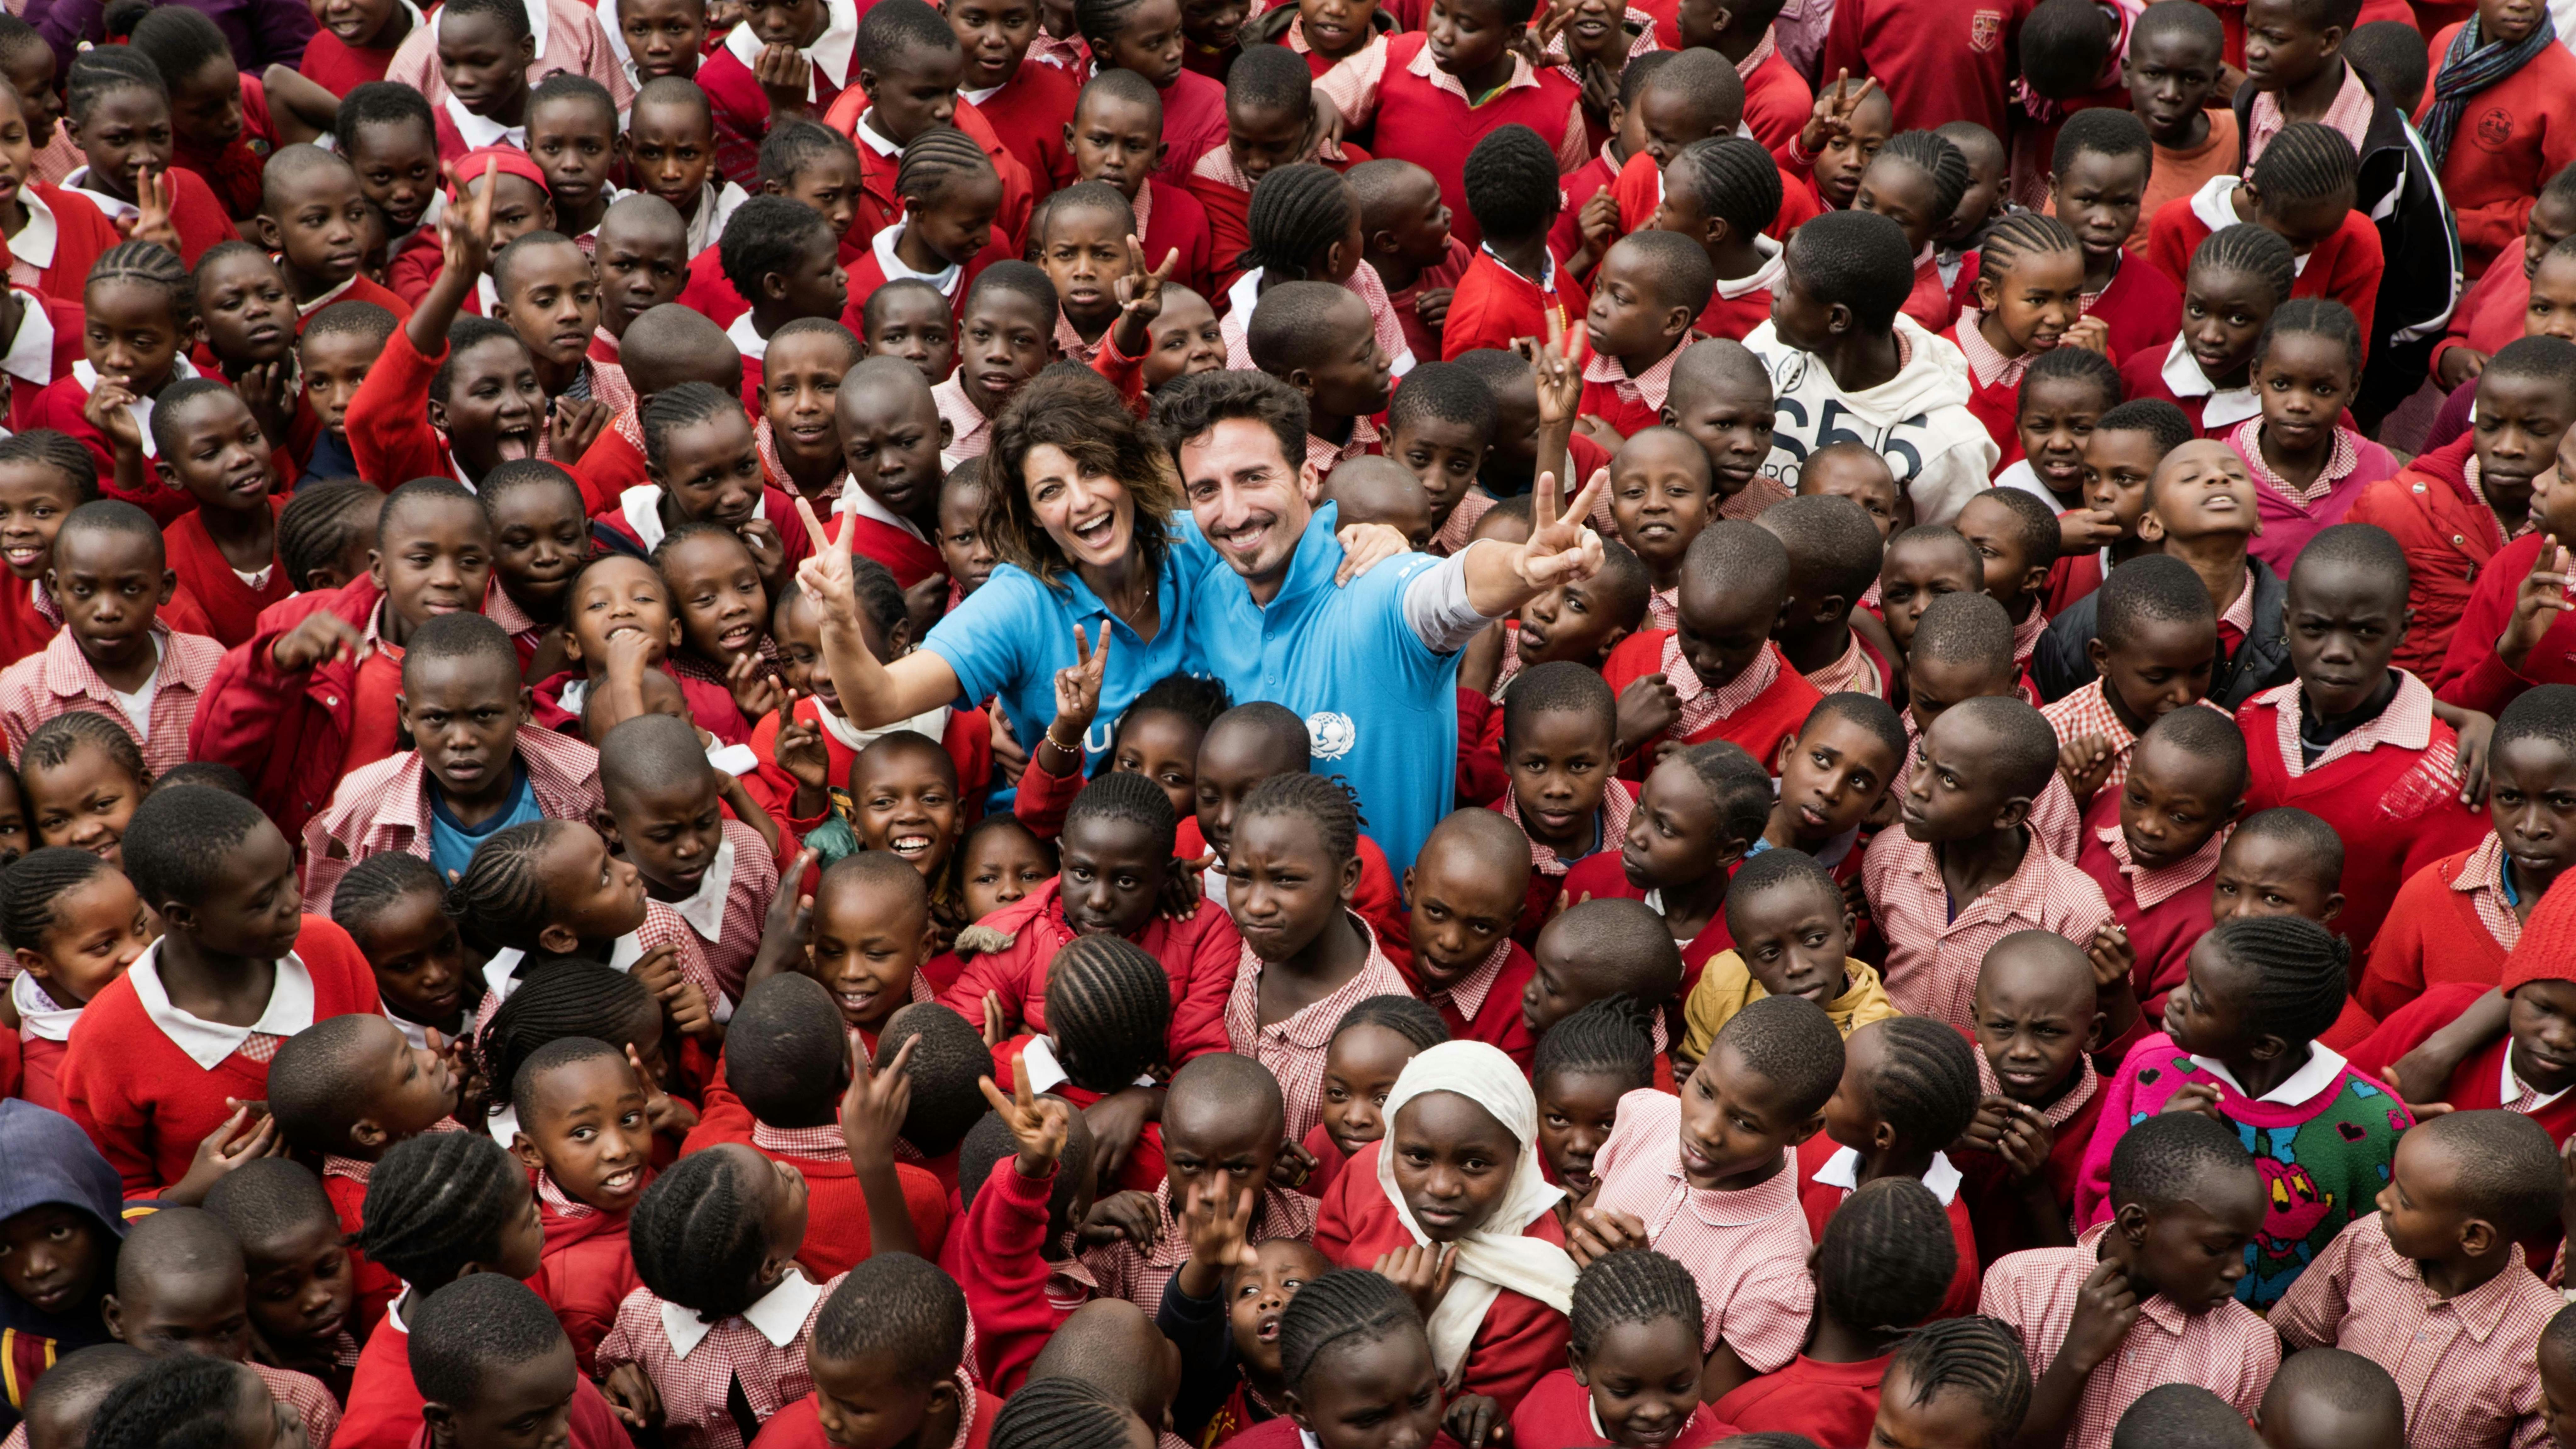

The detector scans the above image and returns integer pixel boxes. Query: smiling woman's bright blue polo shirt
[922,516,1205,771]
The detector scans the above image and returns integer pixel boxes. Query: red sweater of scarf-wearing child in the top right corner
[2414,21,2576,276]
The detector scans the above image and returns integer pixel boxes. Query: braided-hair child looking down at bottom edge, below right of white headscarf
[1512,1248,1731,1449]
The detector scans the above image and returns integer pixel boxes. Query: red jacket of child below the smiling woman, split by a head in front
[940,879,1244,1068]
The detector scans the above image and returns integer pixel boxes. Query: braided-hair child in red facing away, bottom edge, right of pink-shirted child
[1710,1178,1958,1444]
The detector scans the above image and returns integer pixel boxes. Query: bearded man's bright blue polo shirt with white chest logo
[1180,503,1458,874]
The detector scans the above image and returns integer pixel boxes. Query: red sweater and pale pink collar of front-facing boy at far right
[2236,670,2486,954]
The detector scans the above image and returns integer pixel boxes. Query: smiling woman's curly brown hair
[981,364,1185,588]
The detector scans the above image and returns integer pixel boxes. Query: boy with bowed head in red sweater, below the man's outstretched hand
[1602,518,1824,779]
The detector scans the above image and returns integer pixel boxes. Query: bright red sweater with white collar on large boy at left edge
[62,915,384,1199]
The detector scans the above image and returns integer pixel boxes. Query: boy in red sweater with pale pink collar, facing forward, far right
[2236,513,2519,952]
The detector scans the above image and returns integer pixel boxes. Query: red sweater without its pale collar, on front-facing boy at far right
[2236,680,2493,957]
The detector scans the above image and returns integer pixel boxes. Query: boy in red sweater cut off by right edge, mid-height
[2354,683,2576,1011]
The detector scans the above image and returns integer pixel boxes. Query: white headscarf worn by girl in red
[1378,1042,1574,1387]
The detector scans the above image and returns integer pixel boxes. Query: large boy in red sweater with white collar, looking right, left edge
[62,786,384,1202]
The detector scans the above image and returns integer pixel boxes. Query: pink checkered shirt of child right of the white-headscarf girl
[1592,1088,1816,1374]
